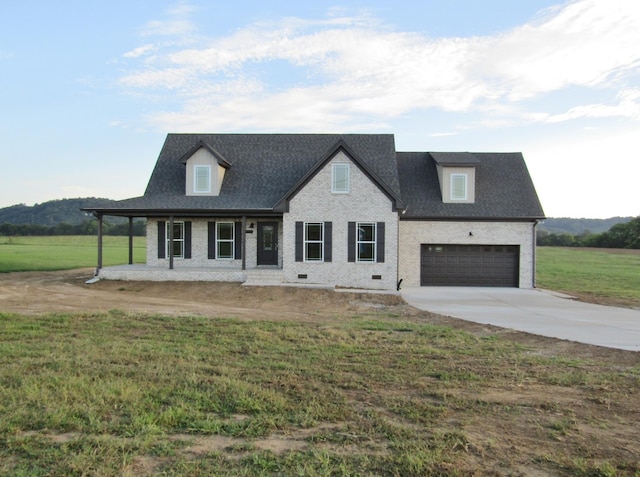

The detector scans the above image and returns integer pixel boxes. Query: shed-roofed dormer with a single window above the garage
[429,152,480,204]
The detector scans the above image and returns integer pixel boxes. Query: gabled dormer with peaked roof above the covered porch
[181,141,231,196]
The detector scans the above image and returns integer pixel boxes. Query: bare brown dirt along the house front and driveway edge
[0,269,640,475]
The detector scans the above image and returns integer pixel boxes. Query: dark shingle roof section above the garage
[397,152,544,220]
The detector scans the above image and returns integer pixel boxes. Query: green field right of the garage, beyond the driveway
[536,247,640,303]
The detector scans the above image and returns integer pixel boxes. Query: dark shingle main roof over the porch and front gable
[90,134,400,216]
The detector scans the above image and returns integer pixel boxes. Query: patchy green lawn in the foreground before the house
[0,311,640,476]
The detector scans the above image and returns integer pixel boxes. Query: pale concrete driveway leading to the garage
[401,287,640,351]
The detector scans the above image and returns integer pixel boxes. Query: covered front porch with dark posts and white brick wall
[86,209,282,284]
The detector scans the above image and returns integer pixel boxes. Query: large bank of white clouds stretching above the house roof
[120,0,640,130]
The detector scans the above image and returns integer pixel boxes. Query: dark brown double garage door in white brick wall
[420,244,520,287]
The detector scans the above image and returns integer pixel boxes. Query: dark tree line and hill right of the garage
[536,216,640,249]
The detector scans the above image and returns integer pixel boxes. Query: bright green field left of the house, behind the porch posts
[0,236,146,273]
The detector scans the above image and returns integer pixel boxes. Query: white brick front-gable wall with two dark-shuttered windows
[282,152,398,290]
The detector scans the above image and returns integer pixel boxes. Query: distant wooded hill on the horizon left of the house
[0,197,116,227]
